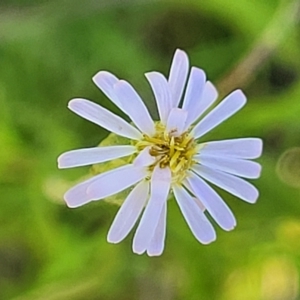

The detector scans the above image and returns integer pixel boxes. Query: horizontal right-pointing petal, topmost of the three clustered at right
[199,138,262,159]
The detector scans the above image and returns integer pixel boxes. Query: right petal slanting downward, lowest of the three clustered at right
[192,165,259,203]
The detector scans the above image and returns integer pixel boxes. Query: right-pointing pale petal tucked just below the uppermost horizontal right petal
[194,152,261,178]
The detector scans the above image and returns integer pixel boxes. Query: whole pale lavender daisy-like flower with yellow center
[58,50,262,256]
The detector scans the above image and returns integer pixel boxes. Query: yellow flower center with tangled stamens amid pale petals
[137,123,197,183]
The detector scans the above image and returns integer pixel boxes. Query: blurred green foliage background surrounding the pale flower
[0,0,300,300]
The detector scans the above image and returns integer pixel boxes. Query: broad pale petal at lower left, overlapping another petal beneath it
[87,165,147,200]
